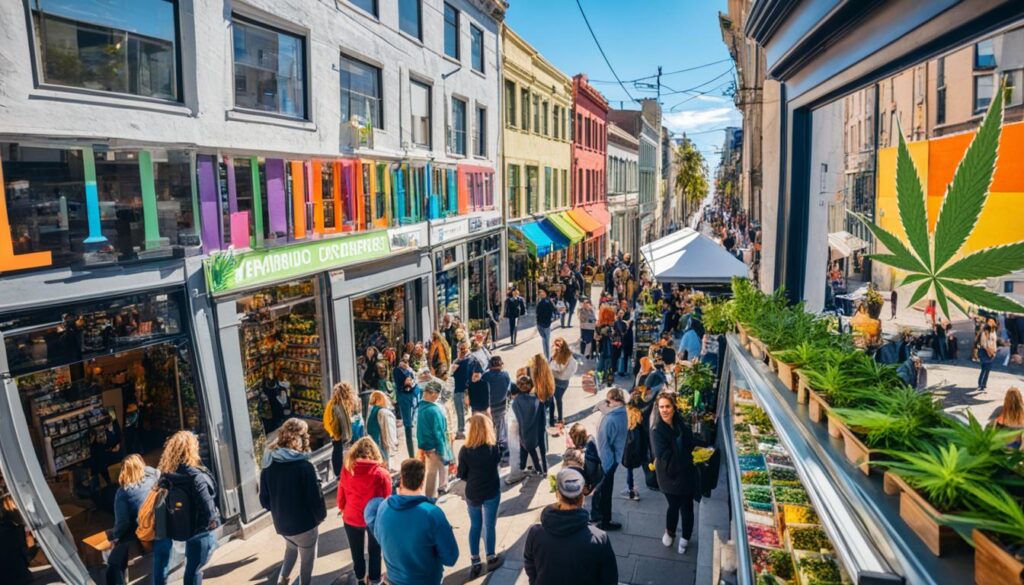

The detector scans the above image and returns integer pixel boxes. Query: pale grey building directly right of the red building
[607,122,640,258]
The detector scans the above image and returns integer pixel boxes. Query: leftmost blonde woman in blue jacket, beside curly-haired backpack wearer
[106,455,157,585]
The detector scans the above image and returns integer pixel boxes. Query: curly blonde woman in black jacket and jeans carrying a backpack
[153,430,220,585]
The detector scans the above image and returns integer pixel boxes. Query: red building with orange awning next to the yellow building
[569,73,611,261]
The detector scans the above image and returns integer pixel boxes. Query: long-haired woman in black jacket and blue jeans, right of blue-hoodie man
[459,413,502,579]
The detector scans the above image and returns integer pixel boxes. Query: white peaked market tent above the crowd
[640,227,748,284]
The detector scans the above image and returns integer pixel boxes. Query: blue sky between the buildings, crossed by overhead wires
[506,0,740,172]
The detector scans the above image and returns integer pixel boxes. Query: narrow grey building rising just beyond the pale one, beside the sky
[608,110,662,246]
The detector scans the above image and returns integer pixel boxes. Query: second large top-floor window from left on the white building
[232,15,306,118]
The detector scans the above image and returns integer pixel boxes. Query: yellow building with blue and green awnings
[502,26,583,300]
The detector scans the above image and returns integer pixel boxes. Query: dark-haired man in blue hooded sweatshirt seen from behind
[364,459,459,585]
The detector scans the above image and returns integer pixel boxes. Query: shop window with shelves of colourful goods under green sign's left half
[236,280,330,466]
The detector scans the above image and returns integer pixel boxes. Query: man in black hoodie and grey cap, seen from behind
[523,467,618,585]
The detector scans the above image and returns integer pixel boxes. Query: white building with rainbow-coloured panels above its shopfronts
[0,0,507,582]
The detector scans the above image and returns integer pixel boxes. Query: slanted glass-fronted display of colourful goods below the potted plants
[733,387,845,585]
